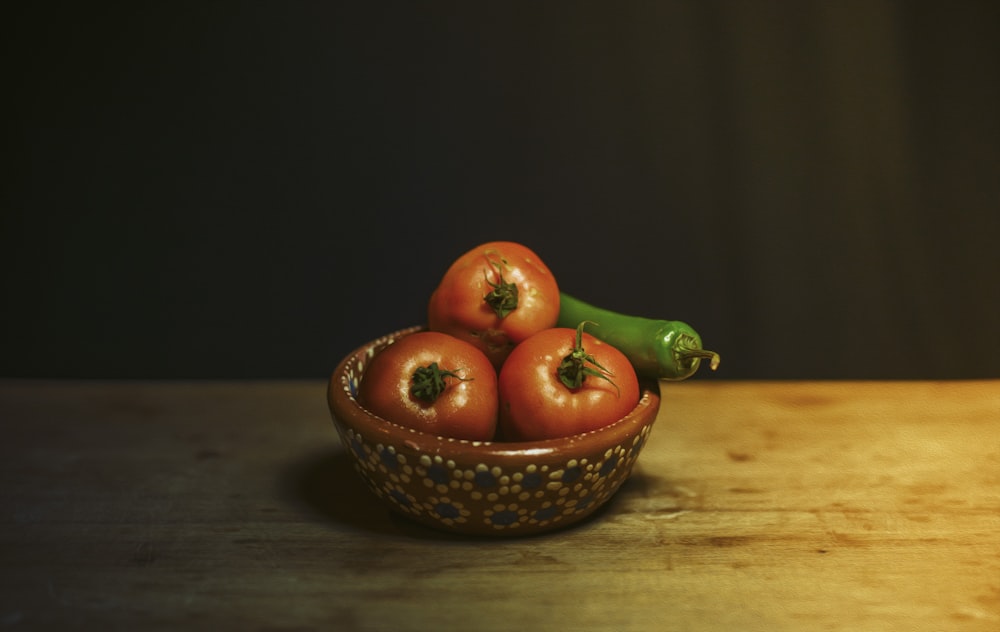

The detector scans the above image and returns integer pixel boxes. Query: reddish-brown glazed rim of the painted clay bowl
[327,325,661,461]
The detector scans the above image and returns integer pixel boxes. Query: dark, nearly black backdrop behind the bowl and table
[0,0,1000,379]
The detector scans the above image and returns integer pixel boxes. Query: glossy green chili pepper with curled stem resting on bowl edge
[556,292,719,380]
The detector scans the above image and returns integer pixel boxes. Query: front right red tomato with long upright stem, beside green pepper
[499,327,639,441]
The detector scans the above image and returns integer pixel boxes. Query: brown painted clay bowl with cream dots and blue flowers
[327,327,660,536]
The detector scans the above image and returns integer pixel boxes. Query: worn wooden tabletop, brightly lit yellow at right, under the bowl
[0,377,1000,632]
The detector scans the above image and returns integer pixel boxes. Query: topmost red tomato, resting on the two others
[427,241,559,370]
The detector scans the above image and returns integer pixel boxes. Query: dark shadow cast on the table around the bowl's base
[281,448,664,542]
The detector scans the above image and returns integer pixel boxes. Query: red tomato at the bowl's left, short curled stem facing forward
[358,331,498,441]
